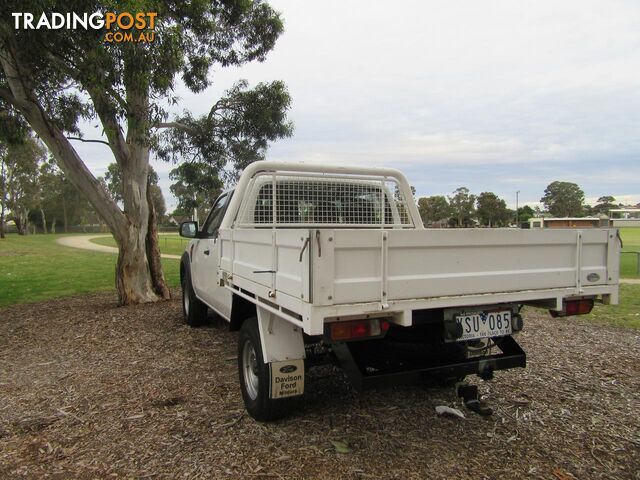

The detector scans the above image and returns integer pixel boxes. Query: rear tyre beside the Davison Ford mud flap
[238,317,295,421]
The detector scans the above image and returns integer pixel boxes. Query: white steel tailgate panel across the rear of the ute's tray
[314,229,610,304]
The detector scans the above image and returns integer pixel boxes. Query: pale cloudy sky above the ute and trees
[72,0,640,211]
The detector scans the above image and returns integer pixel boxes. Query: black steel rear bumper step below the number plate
[333,336,527,390]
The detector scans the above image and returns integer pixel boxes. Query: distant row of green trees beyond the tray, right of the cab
[418,181,622,227]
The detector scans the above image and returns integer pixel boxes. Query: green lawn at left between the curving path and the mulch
[0,234,180,306]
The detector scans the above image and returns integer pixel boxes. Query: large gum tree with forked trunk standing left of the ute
[0,0,291,304]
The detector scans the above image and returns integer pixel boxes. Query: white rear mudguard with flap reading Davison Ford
[257,307,305,398]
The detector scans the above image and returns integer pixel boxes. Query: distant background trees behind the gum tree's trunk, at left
[0,132,228,236]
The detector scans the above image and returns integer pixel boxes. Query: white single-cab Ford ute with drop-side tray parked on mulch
[180,161,620,420]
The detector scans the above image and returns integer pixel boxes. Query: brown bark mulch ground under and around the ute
[0,292,640,480]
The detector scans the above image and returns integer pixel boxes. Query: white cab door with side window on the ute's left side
[191,192,233,319]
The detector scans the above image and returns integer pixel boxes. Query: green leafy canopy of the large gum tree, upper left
[0,0,292,169]
